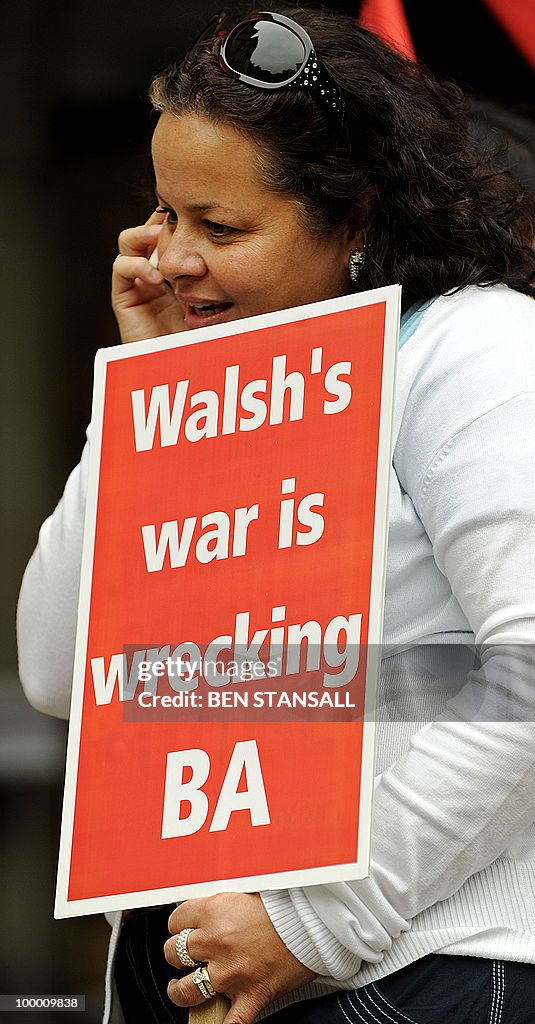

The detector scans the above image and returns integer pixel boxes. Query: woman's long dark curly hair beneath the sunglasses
[150,3,535,309]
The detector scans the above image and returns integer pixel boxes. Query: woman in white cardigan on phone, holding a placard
[18,5,535,1024]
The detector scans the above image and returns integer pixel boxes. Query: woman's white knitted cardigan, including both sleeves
[18,286,535,1010]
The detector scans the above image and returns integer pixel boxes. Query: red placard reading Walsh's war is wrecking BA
[56,287,400,916]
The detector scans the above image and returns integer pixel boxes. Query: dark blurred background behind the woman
[0,0,535,1024]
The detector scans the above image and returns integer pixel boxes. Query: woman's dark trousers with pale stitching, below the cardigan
[115,904,535,1024]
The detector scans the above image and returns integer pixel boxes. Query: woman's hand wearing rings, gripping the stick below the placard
[164,893,316,1024]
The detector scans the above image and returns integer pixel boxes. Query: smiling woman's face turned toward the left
[153,114,356,329]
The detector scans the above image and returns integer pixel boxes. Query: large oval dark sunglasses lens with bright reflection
[220,20,306,85]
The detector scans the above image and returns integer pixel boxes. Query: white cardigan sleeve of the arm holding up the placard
[262,299,535,981]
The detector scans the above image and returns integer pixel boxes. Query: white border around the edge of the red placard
[54,285,401,918]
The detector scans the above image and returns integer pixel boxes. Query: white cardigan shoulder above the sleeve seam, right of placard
[395,285,535,491]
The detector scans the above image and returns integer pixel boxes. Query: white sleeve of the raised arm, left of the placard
[16,431,89,718]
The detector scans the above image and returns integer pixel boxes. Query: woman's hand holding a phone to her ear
[112,210,184,342]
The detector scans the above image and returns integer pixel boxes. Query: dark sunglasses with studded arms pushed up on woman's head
[192,10,341,110]
